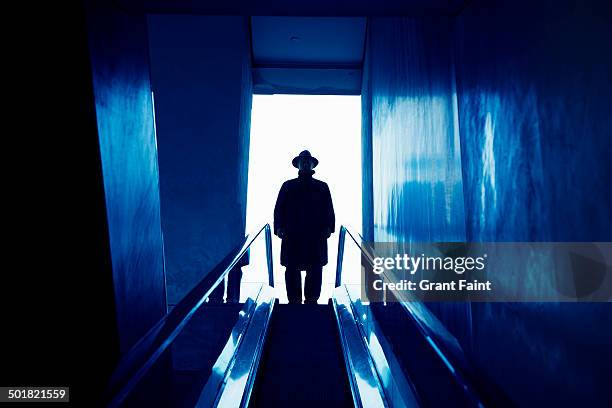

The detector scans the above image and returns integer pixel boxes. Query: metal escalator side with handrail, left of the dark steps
[107,225,272,406]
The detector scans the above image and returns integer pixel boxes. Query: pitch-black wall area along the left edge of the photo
[0,4,119,405]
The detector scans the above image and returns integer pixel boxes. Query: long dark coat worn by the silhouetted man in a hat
[274,171,335,268]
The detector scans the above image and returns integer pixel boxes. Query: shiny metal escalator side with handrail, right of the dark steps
[334,226,481,406]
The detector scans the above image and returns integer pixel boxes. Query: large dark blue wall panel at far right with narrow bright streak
[454,1,612,406]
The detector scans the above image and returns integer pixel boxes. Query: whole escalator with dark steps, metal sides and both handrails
[102,225,498,408]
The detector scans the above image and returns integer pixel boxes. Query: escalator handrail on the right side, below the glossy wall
[336,225,484,406]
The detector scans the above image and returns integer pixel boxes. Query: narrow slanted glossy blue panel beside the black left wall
[86,1,166,352]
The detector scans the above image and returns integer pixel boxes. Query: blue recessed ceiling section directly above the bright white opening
[251,17,366,94]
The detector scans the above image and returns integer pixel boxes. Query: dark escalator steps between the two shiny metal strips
[249,304,353,407]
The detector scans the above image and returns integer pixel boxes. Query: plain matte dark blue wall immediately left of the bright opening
[149,15,252,304]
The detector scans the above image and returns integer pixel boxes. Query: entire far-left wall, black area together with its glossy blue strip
[0,1,164,406]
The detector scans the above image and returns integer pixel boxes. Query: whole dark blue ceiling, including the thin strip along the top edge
[122,0,470,95]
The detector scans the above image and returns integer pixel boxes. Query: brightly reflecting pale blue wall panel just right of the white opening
[368,18,465,241]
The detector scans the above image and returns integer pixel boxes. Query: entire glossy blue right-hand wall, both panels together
[367,1,612,406]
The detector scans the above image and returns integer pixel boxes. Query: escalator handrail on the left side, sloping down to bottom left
[104,223,274,407]
